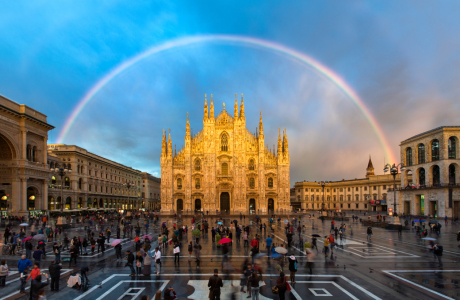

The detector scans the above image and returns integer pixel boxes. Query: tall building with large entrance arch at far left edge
[0,96,54,216]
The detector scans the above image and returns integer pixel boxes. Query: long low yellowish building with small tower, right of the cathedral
[294,157,400,211]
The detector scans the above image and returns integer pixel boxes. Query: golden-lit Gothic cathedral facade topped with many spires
[161,95,290,214]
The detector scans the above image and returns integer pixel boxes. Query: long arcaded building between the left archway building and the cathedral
[47,144,144,212]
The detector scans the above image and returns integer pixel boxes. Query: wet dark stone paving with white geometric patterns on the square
[0,212,460,300]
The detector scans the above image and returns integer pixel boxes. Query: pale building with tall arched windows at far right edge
[389,126,460,218]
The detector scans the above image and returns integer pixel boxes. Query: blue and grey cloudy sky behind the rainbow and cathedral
[0,1,460,184]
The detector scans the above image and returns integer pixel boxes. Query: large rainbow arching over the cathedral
[57,35,397,162]
